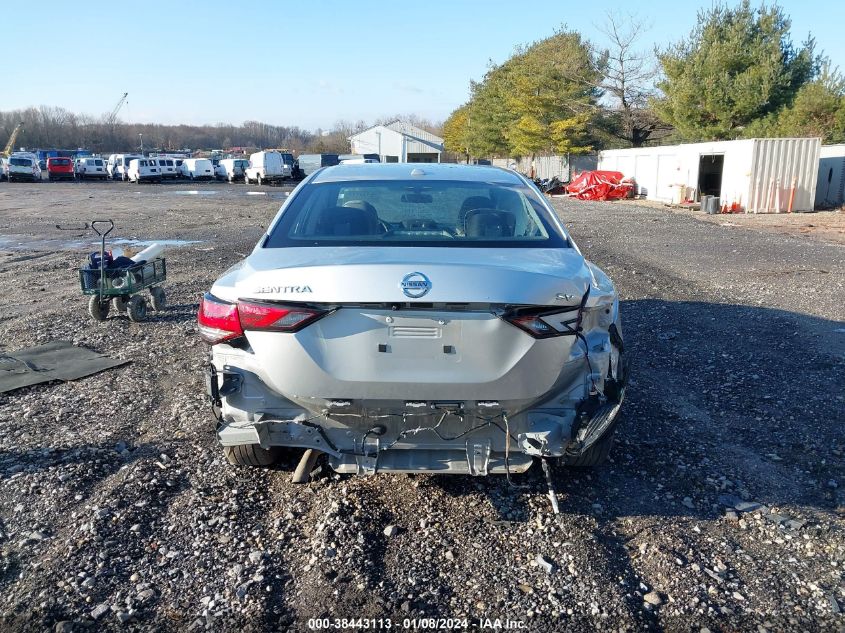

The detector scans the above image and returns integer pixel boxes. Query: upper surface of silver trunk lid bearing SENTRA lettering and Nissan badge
[224,247,592,306]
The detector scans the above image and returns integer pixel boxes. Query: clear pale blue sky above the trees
[0,0,845,130]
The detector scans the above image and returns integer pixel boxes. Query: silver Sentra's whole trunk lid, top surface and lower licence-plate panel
[212,248,591,415]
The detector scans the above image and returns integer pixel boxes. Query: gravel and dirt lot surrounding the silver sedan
[0,183,845,632]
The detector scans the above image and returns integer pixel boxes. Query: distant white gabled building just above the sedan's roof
[349,121,443,163]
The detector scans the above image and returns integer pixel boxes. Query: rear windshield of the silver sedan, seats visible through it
[264,180,569,248]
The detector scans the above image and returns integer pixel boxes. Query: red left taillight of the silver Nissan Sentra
[197,293,328,345]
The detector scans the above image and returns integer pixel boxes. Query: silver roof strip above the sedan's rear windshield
[311,163,523,185]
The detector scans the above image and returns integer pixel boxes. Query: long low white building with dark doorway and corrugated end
[599,138,821,213]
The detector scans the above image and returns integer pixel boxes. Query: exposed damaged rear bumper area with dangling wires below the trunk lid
[206,359,628,476]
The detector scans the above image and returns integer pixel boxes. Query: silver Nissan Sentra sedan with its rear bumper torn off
[198,164,626,475]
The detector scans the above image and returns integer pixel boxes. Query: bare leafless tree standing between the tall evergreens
[598,12,671,147]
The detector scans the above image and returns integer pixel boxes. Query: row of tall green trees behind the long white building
[443,0,845,159]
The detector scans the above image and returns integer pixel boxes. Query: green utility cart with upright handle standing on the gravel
[71,220,167,323]
